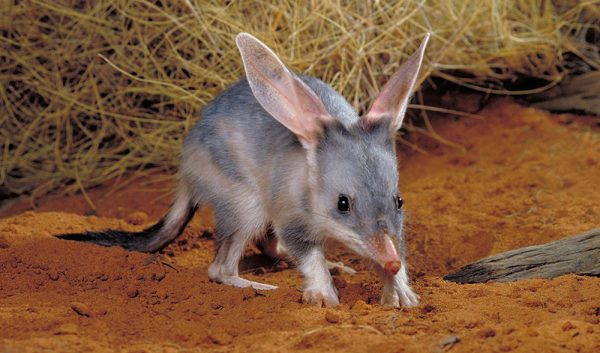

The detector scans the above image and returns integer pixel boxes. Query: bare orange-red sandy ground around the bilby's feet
[0,97,600,353]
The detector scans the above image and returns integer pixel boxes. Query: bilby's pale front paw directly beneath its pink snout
[378,261,419,308]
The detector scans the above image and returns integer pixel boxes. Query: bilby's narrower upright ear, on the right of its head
[363,33,430,133]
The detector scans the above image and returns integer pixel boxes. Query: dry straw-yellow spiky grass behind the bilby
[0,0,600,199]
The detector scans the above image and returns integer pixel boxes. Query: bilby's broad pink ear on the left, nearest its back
[235,33,333,148]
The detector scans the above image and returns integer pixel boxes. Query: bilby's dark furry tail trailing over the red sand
[56,188,198,252]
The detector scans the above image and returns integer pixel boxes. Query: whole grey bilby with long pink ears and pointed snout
[59,33,429,307]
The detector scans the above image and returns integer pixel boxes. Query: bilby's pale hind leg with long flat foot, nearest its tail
[208,199,277,290]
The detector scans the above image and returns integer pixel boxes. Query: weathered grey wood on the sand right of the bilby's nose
[444,228,600,283]
